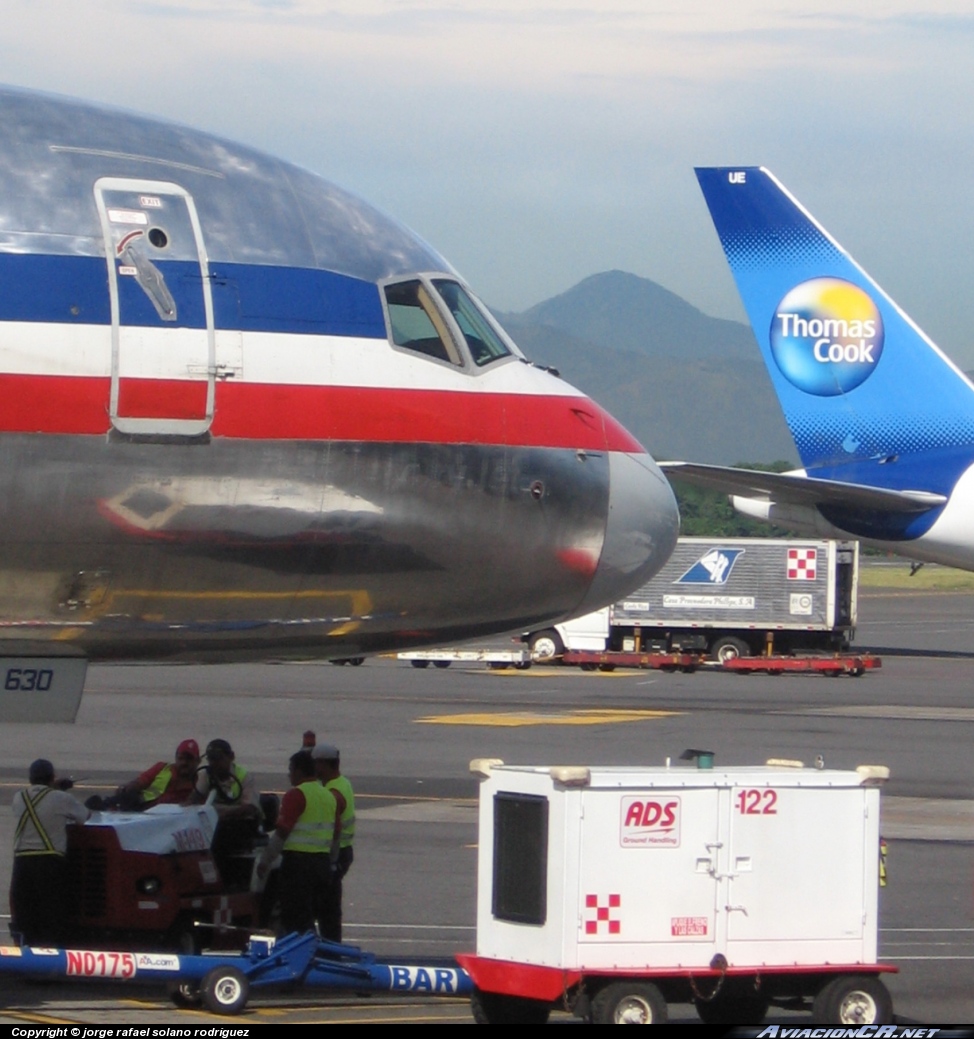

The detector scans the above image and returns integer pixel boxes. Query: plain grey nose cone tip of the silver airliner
[575,451,680,616]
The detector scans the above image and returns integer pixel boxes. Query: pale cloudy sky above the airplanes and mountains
[0,0,974,368]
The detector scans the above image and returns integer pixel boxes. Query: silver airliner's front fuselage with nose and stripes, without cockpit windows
[0,91,677,659]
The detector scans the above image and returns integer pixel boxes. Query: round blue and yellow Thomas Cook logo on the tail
[771,277,884,397]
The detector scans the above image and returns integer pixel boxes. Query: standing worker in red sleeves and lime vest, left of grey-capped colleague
[257,750,338,933]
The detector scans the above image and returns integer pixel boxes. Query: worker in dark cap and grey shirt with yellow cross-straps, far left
[10,757,89,949]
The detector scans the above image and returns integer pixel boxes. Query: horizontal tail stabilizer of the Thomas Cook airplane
[659,461,947,512]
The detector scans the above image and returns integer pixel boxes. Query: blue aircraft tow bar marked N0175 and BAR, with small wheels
[0,933,473,1014]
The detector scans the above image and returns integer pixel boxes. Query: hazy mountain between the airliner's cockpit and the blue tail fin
[498,271,797,464]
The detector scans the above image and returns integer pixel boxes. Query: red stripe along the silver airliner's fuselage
[0,375,644,453]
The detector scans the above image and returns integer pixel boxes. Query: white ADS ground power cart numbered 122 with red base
[458,756,895,1024]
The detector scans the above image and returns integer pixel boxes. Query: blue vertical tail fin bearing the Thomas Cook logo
[696,166,974,475]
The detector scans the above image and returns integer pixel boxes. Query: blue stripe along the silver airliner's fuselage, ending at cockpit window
[0,252,386,339]
